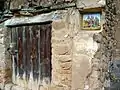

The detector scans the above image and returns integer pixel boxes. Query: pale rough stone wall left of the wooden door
[0,28,11,88]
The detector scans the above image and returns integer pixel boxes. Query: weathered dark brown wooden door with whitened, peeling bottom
[10,23,51,90]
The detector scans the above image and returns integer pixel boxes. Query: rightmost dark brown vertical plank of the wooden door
[44,24,51,83]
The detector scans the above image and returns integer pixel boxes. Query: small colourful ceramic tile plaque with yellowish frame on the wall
[82,13,101,30]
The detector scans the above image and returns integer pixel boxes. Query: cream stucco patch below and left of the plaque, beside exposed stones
[66,10,101,90]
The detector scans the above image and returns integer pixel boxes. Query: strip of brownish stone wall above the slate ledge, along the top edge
[10,0,73,9]
